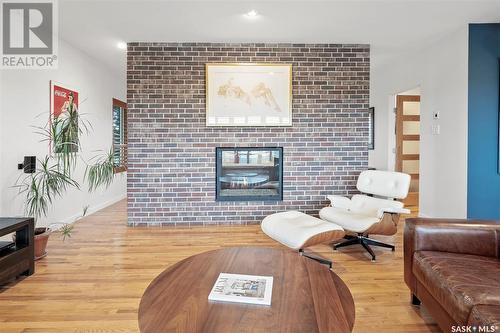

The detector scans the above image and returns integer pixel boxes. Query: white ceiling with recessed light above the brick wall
[59,0,500,75]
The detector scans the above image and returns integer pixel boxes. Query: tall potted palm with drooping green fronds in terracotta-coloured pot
[15,106,114,259]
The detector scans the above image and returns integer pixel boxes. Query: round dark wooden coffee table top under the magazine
[139,247,354,333]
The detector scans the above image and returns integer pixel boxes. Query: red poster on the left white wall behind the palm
[50,81,80,153]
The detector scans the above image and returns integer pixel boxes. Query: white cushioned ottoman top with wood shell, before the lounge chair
[260,211,345,250]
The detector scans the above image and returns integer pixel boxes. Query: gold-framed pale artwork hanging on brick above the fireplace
[205,64,292,127]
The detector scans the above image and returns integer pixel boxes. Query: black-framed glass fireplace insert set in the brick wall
[216,147,283,201]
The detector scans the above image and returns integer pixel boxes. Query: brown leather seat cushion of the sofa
[413,251,500,325]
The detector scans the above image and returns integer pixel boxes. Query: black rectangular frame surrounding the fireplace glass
[215,147,284,201]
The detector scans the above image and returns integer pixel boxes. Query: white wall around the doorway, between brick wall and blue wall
[369,25,468,218]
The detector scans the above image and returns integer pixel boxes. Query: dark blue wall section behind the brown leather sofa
[467,24,500,219]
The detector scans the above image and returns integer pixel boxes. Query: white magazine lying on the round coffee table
[208,273,273,305]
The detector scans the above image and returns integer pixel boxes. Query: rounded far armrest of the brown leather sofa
[404,218,500,291]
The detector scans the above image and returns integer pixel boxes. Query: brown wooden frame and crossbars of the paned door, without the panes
[395,95,420,171]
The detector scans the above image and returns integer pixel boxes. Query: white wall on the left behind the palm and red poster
[0,41,126,225]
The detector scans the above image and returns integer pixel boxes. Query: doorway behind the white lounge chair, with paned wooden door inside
[395,90,420,210]
